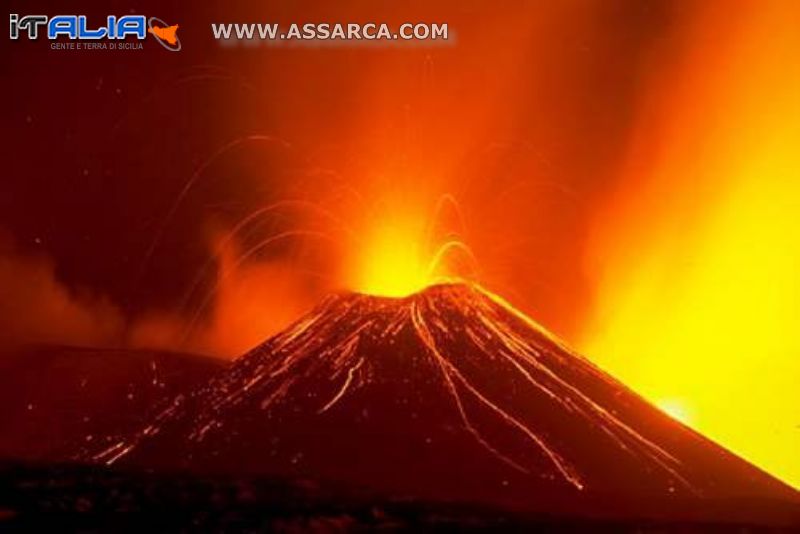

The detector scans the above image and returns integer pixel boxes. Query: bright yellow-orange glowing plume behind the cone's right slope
[579,2,800,488]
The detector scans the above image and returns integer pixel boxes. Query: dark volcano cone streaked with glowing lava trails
[95,284,796,509]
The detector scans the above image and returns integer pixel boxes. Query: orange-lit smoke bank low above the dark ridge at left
[0,229,314,358]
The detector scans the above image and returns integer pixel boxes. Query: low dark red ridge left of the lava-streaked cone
[0,345,225,462]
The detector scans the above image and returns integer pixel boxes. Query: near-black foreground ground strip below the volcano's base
[0,465,800,532]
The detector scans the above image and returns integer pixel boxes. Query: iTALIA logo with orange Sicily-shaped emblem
[9,13,181,52]
